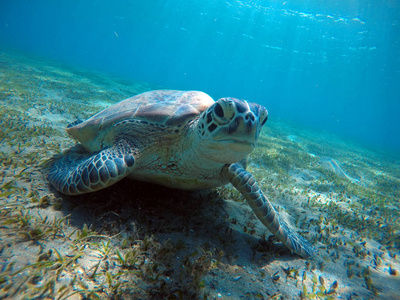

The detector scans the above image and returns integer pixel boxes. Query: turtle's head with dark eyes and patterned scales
[197,98,268,163]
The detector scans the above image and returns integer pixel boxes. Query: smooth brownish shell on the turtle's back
[67,90,214,152]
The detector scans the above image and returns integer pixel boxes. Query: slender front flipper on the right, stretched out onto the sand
[222,164,316,258]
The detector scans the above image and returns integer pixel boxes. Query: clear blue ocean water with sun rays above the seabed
[0,0,400,153]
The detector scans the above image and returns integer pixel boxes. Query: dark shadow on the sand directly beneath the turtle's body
[54,175,298,259]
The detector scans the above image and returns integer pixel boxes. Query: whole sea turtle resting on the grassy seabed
[48,90,315,257]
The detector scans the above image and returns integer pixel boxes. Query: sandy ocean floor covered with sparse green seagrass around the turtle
[0,52,400,299]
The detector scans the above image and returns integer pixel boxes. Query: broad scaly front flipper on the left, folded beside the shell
[48,141,135,195]
